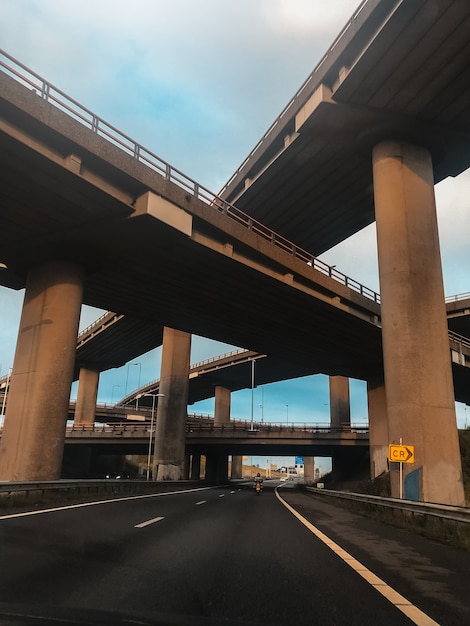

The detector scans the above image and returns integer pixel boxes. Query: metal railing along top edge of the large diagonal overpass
[0,50,380,302]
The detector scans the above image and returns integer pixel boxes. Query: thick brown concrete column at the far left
[0,261,84,481]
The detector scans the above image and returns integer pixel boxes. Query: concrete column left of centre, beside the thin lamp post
[153,327,191,480]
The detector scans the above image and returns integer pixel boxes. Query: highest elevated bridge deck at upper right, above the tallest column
[219,0,470,255]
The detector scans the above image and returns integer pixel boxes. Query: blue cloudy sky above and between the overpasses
[0,0,470,456]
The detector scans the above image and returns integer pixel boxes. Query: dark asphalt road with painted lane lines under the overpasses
[0,485,470,626]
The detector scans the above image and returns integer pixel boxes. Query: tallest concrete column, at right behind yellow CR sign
[373,140,465,505]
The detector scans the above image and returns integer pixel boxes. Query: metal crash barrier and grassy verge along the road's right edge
[303,486,470,551]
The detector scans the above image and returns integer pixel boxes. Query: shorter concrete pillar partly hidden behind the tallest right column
[367,376,390,479]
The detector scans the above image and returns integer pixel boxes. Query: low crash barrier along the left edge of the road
[0,478,201,508]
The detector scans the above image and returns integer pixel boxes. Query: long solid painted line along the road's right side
[275,487,439,626]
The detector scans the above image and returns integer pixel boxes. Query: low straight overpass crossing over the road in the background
[58,414,370,480]
